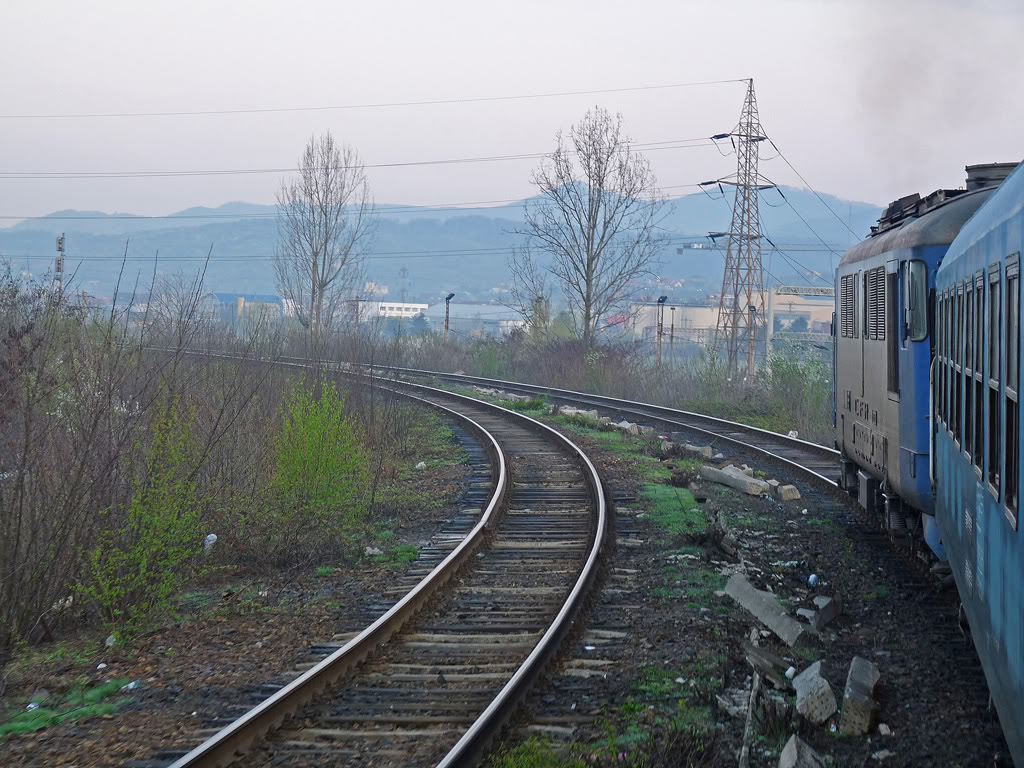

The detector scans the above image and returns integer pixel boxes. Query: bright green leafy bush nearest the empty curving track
[242,382,370,565]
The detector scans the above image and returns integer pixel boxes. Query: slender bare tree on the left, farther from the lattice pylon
[273,132,375,347]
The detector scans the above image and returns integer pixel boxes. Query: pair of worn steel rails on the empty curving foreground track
[154,349,608,768]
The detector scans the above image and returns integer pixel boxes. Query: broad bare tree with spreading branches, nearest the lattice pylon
[509,106,665,347]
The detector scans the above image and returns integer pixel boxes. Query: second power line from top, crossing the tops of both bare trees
[0,136,714,180]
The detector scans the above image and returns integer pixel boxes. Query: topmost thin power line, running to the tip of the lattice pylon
[0,80,746,120]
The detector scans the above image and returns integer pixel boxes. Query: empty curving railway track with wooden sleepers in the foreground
[148,376,608,768]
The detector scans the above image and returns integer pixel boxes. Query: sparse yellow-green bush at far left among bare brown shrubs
[78,398,202,636]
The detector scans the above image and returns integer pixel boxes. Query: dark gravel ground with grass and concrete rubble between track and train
[444,391,1006,768]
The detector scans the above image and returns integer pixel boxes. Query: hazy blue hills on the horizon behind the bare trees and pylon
[0,187,881,300]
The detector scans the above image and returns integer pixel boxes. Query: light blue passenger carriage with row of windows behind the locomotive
[932,164,1024,765]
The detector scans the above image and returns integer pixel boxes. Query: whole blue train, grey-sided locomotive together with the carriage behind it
[833,163,1024,765]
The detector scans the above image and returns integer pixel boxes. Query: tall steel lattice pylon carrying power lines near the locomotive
[703,78,775,381]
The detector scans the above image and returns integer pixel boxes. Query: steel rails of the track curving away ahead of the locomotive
[358,366,840,486]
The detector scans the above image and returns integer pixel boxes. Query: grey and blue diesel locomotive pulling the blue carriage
[834,164,1014,559]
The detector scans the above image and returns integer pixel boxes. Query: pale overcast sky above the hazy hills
[0,0,1024,216]
